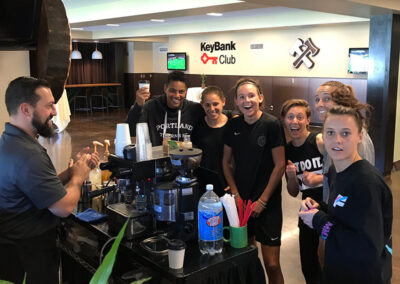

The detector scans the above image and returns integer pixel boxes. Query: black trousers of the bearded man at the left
[0,229,60,284]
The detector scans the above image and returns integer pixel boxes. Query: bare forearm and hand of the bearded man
[48,154,90,217]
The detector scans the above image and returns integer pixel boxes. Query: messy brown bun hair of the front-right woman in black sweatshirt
[321,81,372,128]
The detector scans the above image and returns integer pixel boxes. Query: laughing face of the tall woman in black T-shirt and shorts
[235,84,264,118]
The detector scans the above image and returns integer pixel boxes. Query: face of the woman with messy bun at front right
[322,114,362,171]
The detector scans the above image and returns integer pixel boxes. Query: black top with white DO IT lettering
[286,133,323,202]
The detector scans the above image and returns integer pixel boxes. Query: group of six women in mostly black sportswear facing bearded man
[127,71,393,284]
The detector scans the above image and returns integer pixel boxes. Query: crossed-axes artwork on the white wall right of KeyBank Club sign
[289,38,319,69]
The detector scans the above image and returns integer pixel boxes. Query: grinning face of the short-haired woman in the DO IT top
[284,106,310,139]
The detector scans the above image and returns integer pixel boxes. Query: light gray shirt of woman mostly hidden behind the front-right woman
[322,128,375,202]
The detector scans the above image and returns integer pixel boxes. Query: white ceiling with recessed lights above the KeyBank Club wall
[63,0,400,41]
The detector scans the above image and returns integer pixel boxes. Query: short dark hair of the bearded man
[6,77,50,115]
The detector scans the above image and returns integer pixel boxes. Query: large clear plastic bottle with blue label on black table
[198,184,224,255]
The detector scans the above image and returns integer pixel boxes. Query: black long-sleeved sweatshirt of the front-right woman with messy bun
[313,160,393,284]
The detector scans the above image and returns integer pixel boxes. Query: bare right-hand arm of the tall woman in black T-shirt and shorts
[252,146,285,217]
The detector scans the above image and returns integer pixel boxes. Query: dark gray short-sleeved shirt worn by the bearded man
[0,123,66,242]
